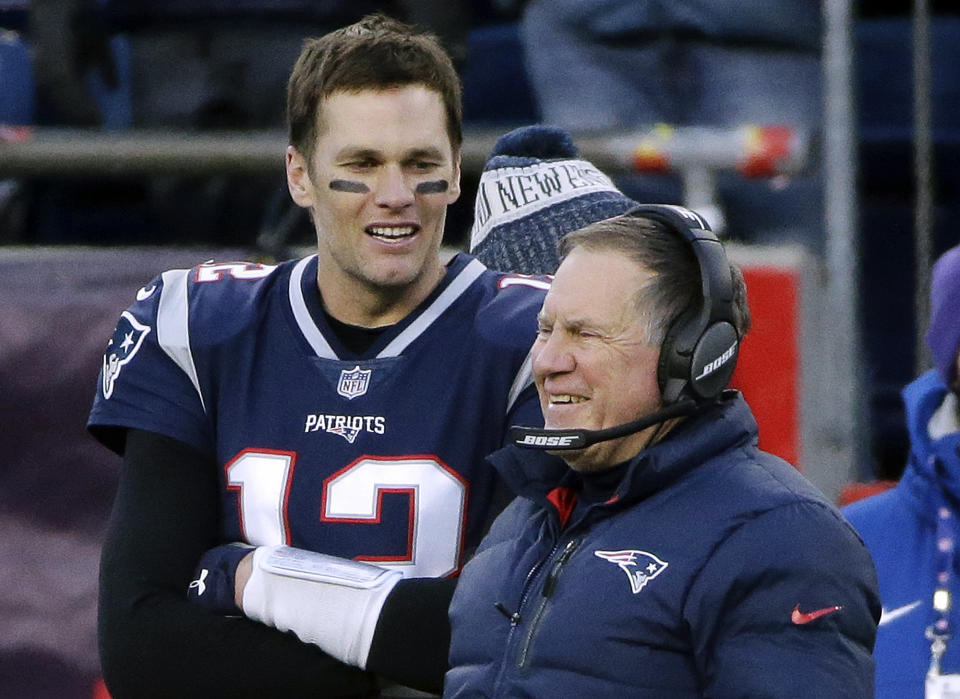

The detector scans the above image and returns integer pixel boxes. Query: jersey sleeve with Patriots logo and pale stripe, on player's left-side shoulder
[87,270,213,460]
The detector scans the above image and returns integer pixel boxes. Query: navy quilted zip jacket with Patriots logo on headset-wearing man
[444,394,880,699]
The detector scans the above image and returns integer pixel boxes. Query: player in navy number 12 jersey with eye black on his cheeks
[89,16,572,699]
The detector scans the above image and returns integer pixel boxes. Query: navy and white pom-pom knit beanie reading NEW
[470,125,637,274]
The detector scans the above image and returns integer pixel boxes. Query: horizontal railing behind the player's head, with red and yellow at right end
[0,125,809,182]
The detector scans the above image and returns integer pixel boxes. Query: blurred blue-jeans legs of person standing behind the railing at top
[522,0,823,251]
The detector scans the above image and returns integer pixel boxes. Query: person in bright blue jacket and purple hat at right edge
[844,246,960,699]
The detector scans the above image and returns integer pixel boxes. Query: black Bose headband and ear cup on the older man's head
[627,204,740,405]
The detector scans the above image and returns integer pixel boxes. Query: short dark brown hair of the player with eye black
[287,13,463,161]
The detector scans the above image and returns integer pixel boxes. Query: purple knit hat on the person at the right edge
[927,245,960,386]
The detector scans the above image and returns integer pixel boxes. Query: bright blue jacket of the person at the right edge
[844,371,960,699]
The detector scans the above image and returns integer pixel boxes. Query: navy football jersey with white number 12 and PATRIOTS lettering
[89,254,549,577]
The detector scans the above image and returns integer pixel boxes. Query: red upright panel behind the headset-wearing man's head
[730,263,801,468]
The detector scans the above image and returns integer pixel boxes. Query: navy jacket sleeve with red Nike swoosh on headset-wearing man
[684,502,880,699]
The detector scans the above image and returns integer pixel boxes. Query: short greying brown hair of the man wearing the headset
[560,214,750,347]
